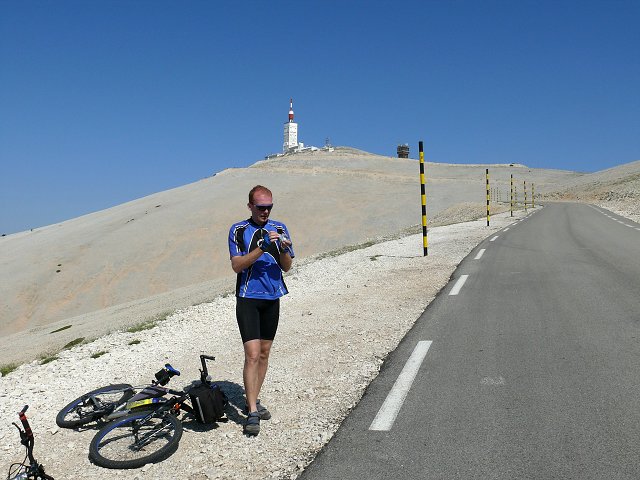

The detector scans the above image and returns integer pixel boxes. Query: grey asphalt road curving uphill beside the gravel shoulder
[301,203,640,480]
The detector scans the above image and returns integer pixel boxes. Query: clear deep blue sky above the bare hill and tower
[0,0,640,233]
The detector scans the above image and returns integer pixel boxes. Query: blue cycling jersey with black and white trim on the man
[229,218,295,300]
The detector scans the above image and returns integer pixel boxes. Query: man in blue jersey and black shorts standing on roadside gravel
[229,185,295,435]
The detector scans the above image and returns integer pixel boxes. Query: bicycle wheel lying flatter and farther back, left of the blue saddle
[56,383,133,428]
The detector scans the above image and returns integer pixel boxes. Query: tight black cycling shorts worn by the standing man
[236,297,280,343]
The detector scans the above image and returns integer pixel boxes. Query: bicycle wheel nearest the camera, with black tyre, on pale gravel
[89,411,182,468]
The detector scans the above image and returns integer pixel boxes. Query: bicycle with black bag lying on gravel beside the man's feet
[58,355,227,468]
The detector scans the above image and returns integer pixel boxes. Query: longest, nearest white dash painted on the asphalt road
[369,340,431,431]
